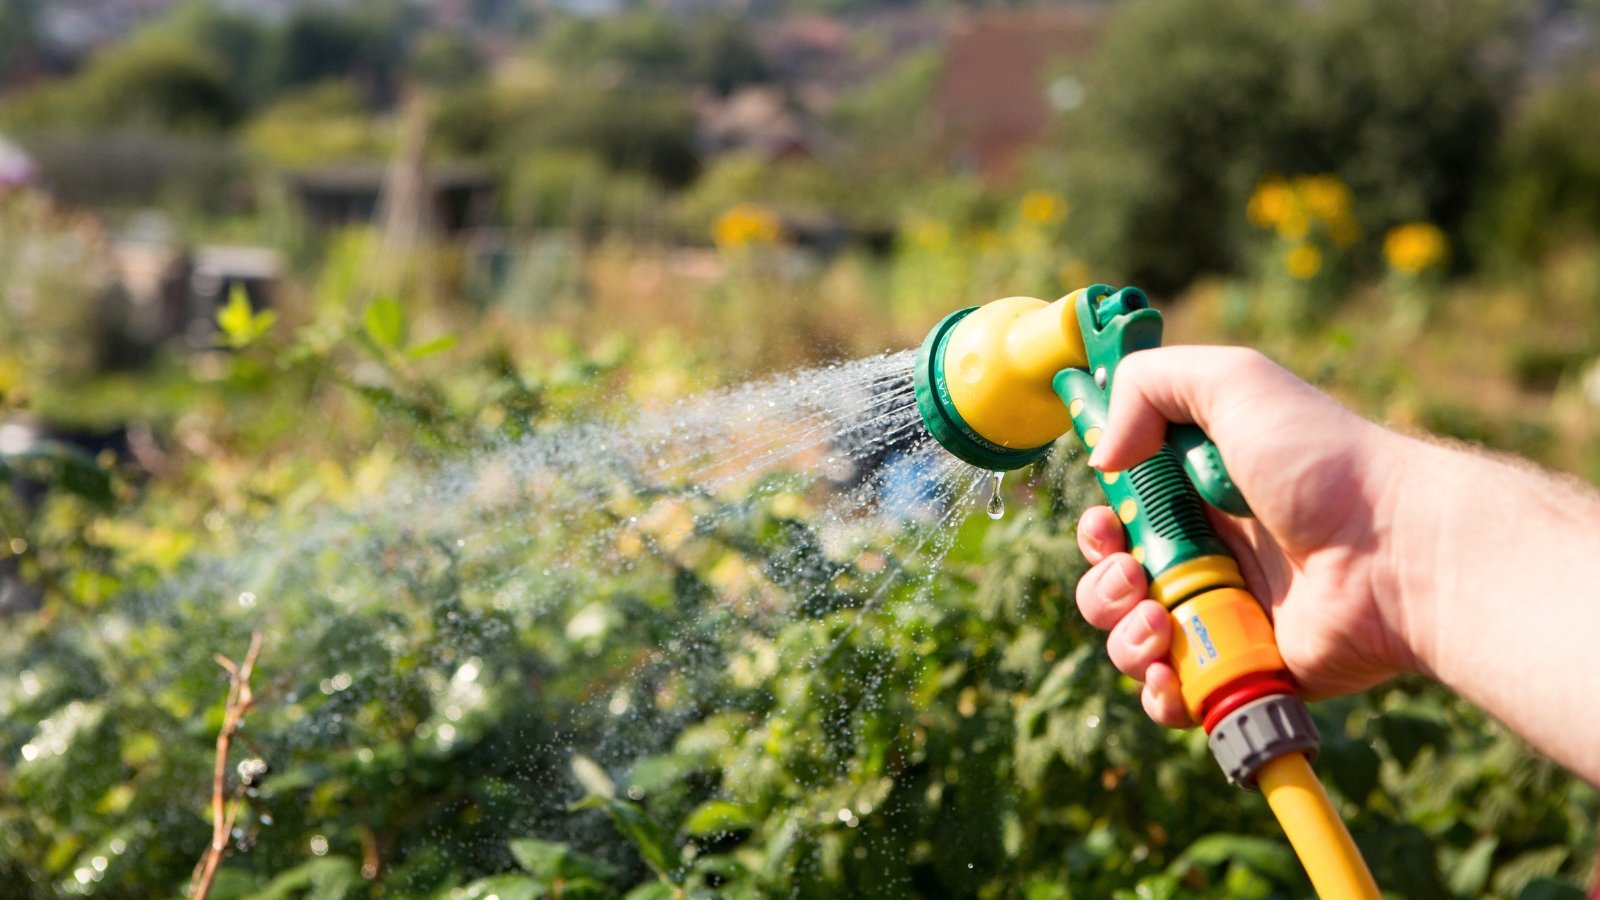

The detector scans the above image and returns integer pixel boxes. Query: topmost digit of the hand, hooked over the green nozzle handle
[1090,348,1286,471]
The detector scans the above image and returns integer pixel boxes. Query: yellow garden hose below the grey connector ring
[1256,753,1379,900]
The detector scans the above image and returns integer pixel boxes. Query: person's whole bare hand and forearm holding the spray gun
[1077,348,1600,783]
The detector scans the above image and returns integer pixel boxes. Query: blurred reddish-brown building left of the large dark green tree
[936,6,1104,179]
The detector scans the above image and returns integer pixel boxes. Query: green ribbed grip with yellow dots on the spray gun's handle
[1053,368,1229,581]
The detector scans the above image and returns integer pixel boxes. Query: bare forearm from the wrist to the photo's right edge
[1390,439,1600,783]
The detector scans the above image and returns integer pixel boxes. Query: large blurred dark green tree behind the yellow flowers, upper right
[1062,0,1512,290]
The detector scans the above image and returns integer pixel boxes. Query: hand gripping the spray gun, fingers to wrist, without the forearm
[1077,348,1416,727]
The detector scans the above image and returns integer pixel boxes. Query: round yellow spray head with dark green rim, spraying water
[914,285,1106,471]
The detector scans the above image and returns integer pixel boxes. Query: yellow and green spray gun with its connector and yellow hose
[914,285,1379,900]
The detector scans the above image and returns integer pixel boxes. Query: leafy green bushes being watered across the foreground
[0,318,1597,900]
